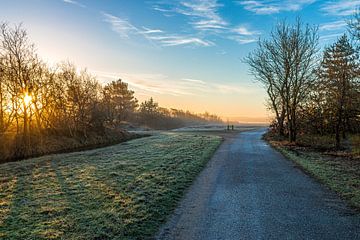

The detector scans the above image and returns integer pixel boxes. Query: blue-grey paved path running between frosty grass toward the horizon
[157,130,360,240]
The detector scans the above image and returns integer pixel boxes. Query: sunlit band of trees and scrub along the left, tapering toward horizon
[0,23,222,162]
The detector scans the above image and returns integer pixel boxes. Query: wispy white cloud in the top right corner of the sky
[321,0,360,16]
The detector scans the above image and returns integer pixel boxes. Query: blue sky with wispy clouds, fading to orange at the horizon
[0,0,360,122]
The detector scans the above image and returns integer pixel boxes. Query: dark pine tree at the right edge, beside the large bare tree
[320,34,359,148]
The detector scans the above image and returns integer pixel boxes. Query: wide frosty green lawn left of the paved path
[0,133,221,239]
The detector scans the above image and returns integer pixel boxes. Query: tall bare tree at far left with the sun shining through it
[0,24,41,146]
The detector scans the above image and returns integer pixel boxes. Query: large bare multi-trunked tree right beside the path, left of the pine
[245,18,318,142]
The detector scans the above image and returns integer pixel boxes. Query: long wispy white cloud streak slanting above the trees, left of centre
[102,12,214,47]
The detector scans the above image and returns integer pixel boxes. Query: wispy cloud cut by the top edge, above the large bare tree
[238,0,316,15]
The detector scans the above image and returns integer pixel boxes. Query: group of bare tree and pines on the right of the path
[245,12,360,149]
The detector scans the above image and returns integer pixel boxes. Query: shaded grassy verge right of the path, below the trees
[270,142,360,210]
